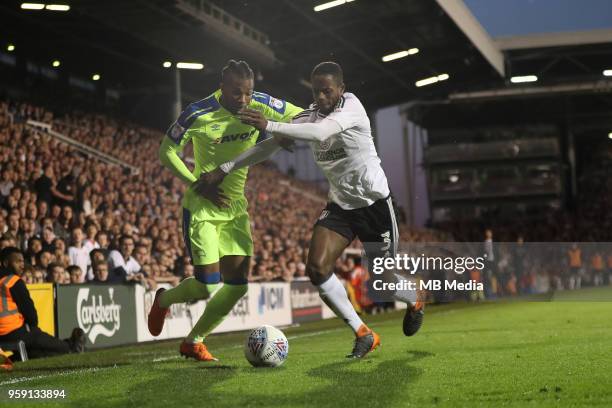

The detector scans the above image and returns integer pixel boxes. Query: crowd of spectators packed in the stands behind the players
[0,101,612,310]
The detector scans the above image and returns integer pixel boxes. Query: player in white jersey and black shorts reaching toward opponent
[201,62,423,358]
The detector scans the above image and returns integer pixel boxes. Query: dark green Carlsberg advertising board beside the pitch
[57,285,137,348]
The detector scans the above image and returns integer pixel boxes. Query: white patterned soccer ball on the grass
[244,326,289,367]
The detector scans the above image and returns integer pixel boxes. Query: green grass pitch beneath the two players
[0,291,612,408]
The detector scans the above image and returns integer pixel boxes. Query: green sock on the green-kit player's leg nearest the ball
[186,283,248,343]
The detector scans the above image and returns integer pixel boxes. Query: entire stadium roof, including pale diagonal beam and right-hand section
[0,0,612,130]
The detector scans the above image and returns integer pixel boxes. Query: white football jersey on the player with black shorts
[292,92,389,210]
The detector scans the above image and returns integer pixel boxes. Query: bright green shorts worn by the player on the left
[183,199,253,265]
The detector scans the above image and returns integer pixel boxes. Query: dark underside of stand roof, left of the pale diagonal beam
[0,0,499,120]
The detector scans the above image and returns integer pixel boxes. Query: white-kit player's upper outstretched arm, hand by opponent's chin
[238,109,342,142]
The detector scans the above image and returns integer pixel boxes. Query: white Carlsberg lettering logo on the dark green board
[77,288,121,344]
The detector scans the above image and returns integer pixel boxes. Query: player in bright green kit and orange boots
[148,60,302,361]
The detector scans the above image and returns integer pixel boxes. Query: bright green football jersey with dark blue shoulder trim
[167,90,303,211]
